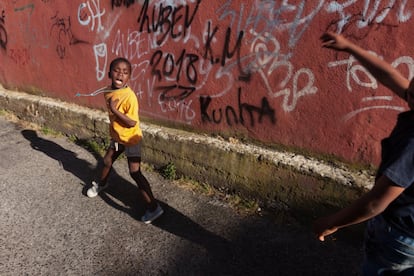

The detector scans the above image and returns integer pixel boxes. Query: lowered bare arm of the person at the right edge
[313,175,404,241]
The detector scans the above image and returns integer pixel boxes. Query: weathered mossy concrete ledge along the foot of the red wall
[0,87,373,210]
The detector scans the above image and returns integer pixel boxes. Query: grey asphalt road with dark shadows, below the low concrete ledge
[0,113,362,275]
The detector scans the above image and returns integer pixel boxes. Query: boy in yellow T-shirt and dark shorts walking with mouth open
[87,58,164,223]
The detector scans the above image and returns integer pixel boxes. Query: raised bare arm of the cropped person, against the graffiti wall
[321,32,410,100]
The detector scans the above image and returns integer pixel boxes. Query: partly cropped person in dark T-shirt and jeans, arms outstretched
[314,32,414,275]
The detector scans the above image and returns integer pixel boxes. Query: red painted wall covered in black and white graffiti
[0,0,414,165]
